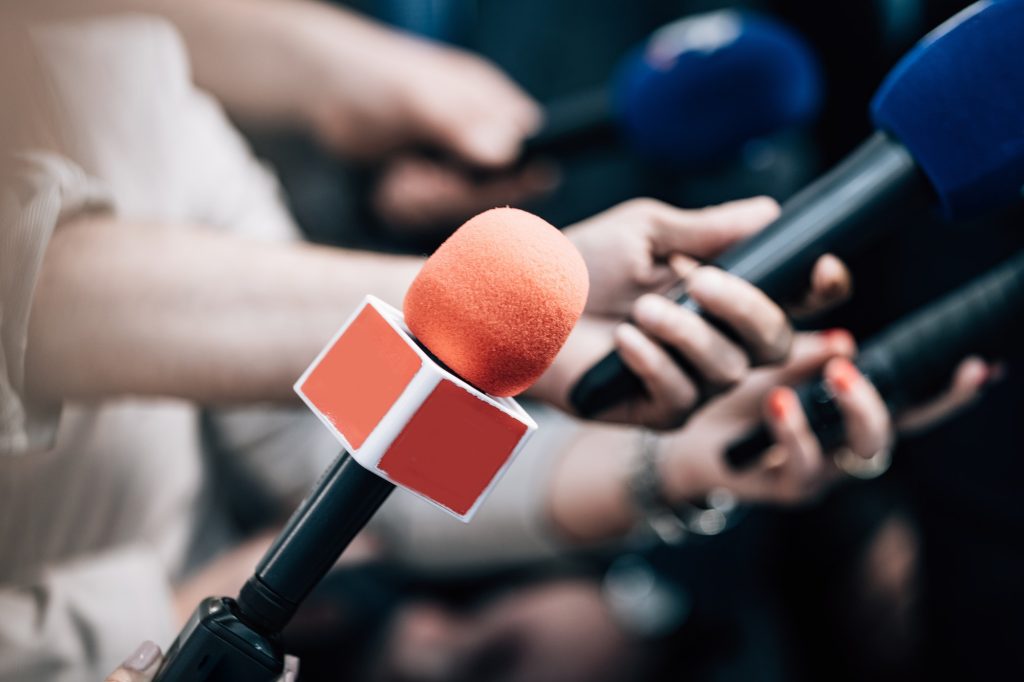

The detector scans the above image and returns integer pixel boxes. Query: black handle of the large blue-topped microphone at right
[569,132,933,417]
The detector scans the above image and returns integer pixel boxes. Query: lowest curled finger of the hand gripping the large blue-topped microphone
[615,324,698,413]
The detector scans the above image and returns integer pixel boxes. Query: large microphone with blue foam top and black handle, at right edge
[569,1,1024,417]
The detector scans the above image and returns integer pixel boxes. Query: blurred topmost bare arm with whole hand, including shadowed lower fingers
[25,0,557,241]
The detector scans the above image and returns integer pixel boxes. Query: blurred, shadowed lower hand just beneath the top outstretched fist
[372,156,559,233]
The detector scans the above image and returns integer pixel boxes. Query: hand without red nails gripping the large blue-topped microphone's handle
[534,198,850,428]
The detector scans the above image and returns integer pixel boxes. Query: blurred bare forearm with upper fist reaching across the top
[35,0,540,166]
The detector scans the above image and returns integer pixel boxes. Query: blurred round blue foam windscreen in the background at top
[613,10,821,168]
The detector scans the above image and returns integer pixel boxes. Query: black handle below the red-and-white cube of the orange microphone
[238,452,394,634]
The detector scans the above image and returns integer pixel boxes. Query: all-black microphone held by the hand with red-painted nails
[725,246,1024,470]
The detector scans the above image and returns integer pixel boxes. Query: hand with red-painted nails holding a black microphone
[659,330,993,505]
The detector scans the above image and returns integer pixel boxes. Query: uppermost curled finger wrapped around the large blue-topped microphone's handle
[686,266,793,364]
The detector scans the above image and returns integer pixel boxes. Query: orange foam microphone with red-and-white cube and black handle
[150,208,589,682]
